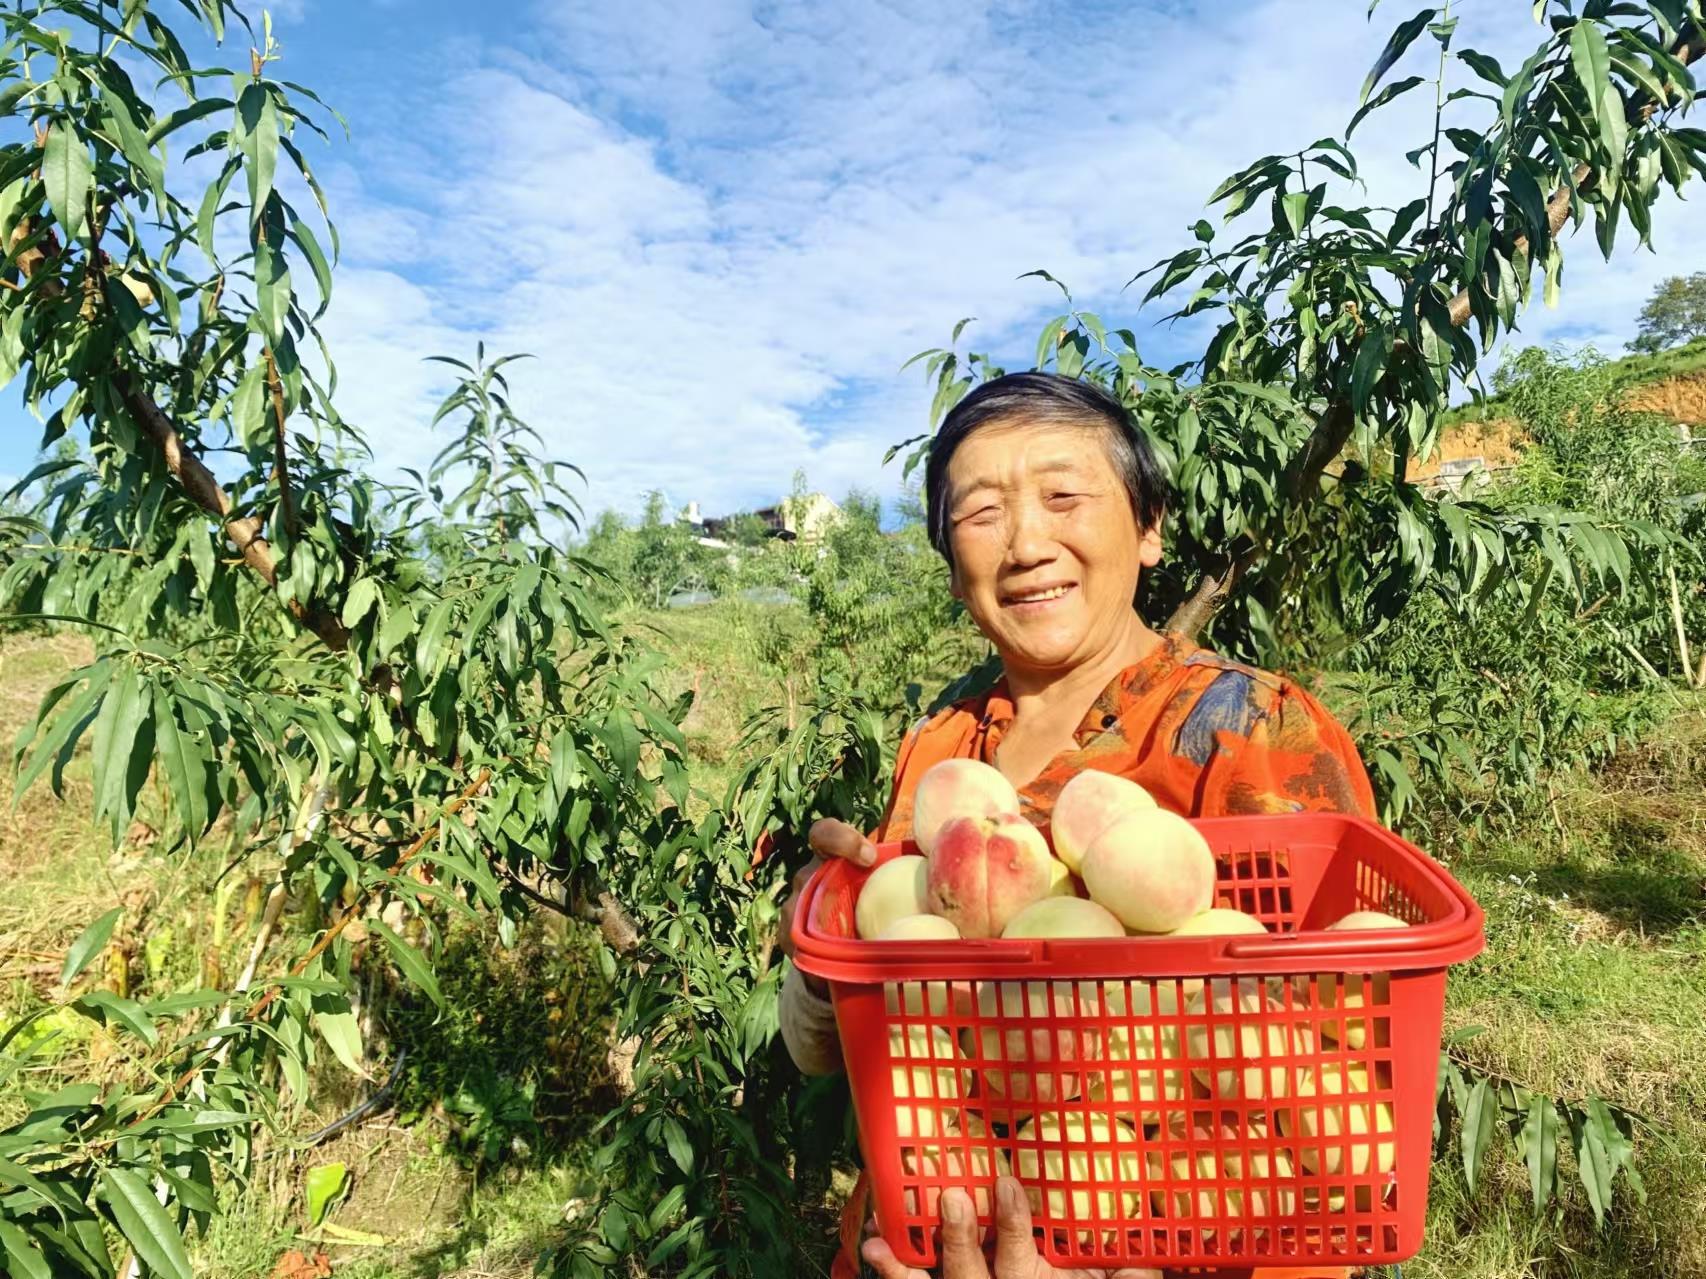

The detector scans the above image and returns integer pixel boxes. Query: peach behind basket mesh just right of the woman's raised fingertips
[1013,1110,1143,1221]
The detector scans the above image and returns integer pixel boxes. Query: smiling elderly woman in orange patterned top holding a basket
[781,373,1373,1279]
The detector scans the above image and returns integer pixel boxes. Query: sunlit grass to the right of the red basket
[1406,723,1706,1279]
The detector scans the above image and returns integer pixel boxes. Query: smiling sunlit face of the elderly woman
[947,420,1162,682]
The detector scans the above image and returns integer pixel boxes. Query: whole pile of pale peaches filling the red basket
[855,759,1406,1219]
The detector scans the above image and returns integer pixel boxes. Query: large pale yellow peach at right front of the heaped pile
[1082,808,1215,933]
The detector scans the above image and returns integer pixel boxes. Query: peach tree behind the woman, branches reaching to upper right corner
[891,0,1706,653]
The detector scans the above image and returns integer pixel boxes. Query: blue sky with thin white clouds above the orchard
[0,0,1706,513]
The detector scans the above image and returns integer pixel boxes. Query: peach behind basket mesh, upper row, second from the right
[1186,977,1315,1102]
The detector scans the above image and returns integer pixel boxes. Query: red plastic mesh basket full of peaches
[793,813,1483,1267]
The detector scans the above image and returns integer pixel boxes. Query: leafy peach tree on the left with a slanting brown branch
[0,0,688,1279]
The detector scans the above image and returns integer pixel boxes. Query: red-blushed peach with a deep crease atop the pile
[928,811,1053,938]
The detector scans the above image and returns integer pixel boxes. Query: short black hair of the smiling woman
[925,372,1167,568]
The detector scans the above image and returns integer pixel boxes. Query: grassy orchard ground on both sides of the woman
[0,617,1706,1279]
